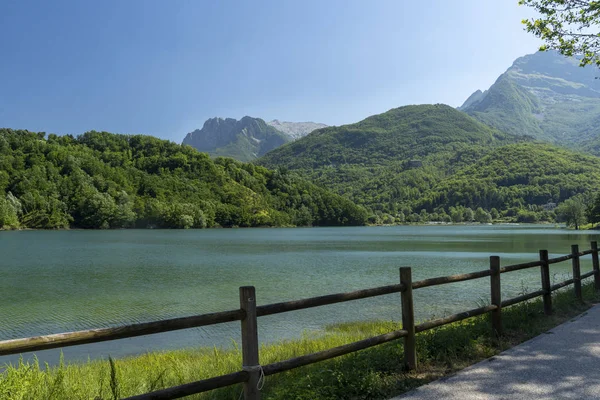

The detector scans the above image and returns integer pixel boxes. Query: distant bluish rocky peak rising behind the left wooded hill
[183,116,292,161]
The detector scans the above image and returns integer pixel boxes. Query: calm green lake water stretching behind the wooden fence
[0,225,598,364]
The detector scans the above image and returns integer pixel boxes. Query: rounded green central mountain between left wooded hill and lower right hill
[255,104,529,214]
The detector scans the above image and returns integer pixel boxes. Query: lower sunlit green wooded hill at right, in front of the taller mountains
[418,143,600,210]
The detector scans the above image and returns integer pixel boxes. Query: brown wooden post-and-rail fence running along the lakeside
[0,242,600,400]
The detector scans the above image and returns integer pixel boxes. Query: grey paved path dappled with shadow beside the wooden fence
[392,305,600,400]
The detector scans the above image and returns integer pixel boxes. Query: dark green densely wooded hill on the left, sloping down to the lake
[0,129,367,229]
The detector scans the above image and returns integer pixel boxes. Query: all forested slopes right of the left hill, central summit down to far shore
[258,105,600,222]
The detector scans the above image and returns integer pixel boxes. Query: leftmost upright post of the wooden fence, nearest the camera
[240,286,261,400]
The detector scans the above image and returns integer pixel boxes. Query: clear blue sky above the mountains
[0,0,540,142]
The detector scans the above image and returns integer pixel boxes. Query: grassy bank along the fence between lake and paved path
[0,284,600,400]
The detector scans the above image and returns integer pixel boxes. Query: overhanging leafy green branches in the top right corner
[519,0,600,67]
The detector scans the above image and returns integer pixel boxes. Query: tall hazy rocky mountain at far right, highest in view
[459,51,600,154]
